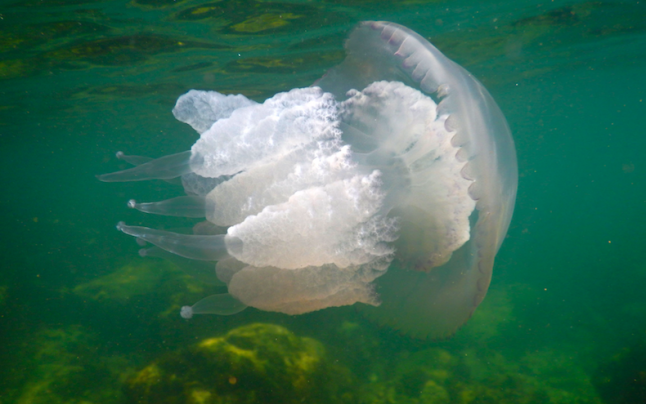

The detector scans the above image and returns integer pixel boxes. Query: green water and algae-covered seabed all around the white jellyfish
[0,0,646,404]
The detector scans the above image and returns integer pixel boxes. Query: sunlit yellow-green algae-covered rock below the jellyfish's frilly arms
[126,324,353,404]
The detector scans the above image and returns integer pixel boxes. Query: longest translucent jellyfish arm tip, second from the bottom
[117,222,229,261]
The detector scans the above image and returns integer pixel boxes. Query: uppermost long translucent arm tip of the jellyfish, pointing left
[97,150,192,182]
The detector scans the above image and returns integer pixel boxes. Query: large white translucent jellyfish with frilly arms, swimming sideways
[98,21,518,338]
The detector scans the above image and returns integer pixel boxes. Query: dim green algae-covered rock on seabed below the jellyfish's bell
[363,348,601,404]
